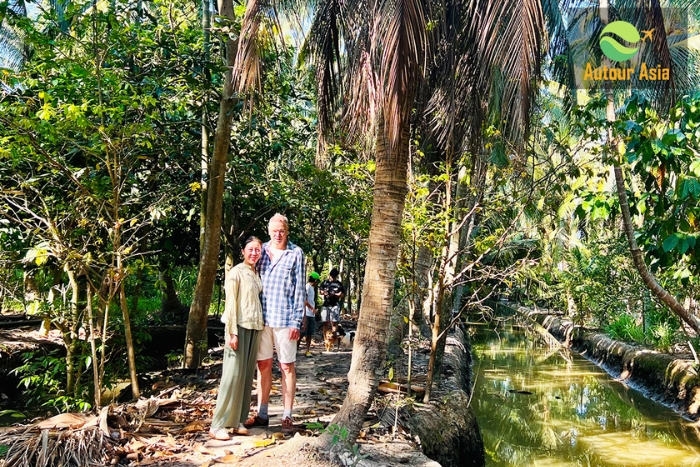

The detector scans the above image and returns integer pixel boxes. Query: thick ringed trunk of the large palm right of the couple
[320,117,409,444]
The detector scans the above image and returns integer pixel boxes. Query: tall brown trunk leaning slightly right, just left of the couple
[183,0,236,369]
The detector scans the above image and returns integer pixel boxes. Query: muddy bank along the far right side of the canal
[518,307,700,420]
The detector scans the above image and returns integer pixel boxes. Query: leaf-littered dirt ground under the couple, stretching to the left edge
[0,322,438,467]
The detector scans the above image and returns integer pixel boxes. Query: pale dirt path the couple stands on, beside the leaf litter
[132,330,439,467]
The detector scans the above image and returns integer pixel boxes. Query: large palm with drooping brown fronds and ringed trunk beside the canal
[308,0,543,439]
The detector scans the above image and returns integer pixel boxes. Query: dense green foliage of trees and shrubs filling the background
[0,0,700,424]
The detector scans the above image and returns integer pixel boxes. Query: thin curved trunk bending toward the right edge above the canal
[599,5,700,334]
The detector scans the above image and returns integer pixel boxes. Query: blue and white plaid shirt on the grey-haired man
[258,241,306,329]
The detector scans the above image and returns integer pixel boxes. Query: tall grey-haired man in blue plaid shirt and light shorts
[243,214,306,432]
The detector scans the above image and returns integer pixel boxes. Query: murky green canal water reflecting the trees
[470,325,700,467]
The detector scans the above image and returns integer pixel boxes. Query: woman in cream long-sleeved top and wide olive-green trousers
[209,237,263,441]
